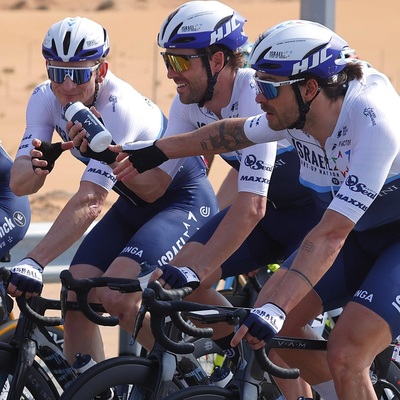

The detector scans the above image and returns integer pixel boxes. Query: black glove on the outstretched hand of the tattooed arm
[122,140,168,173]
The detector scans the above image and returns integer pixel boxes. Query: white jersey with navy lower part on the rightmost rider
[245,67,400,231]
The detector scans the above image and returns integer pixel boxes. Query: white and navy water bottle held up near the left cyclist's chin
[65,101,112,153]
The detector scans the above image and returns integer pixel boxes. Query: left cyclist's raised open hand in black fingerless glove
[31,139,72,173]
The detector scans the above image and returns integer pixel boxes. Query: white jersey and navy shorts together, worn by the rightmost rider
[245,62,400,338]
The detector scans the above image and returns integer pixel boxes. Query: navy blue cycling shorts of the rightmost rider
[284,222,400,338]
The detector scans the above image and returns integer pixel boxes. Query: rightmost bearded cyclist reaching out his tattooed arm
[111,20,400,399]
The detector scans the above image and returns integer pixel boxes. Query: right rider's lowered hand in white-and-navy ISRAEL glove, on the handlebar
[232,303,286,348]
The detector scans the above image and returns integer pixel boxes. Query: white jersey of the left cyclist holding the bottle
[16,70,166,197]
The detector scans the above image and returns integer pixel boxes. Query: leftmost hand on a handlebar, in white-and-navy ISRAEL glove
[8,258,43,297]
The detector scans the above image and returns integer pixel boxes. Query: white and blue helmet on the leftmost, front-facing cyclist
[42,17,110,62]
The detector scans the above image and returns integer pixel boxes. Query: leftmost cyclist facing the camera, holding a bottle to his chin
[9,17,217,361]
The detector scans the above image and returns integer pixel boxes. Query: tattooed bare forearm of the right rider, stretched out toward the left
[157,118,254,158]
